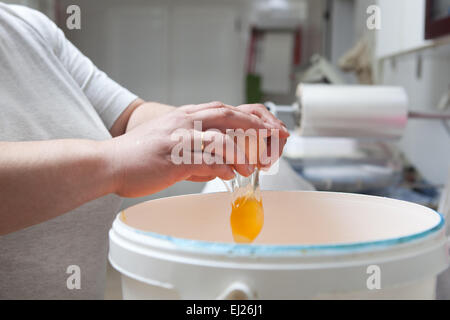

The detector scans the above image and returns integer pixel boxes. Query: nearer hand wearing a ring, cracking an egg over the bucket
[107,102,287,197]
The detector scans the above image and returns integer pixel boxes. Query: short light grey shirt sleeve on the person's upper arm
[10,6,137,129]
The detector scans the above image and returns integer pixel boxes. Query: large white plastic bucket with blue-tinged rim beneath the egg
[109,191,449,299]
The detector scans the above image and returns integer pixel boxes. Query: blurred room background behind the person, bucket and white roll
[5,0,450,297]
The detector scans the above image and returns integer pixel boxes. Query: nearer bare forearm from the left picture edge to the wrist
[0,140,115,234]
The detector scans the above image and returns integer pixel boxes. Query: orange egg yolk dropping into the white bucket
[230,196,264,243]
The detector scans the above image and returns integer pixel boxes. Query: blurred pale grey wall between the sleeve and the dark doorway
[60,0,246,105]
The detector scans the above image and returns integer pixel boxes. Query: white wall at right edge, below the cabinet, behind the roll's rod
[382,46,450,184]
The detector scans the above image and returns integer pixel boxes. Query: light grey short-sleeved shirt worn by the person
[0,3,137,299]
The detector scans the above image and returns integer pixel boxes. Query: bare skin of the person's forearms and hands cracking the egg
[0,99,289,234]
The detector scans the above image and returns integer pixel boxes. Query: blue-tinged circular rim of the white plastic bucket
[113,190,445,257]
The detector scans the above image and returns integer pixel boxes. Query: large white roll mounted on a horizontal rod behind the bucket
[297,84,408,139]
